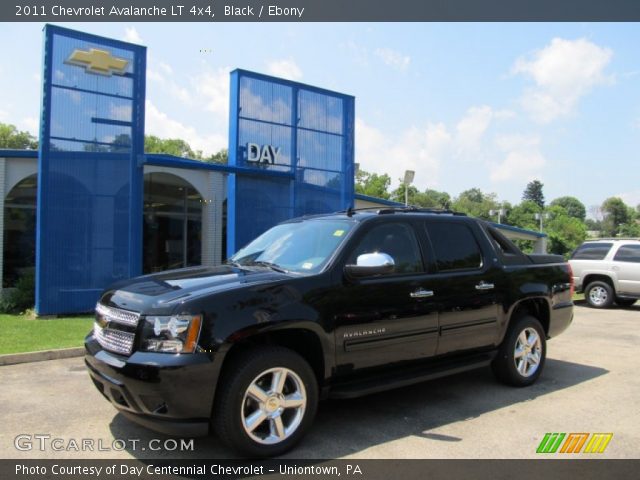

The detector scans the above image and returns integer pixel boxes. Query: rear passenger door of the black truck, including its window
[426,218,502,355]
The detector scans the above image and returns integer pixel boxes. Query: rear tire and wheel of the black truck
[491,315,547,387]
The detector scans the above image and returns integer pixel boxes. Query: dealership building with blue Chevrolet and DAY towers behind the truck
[0,25,544,315]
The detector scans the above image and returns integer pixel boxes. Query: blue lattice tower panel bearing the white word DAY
[227,70,354,255]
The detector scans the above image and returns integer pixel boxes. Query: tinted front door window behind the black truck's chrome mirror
[347,223,422,273]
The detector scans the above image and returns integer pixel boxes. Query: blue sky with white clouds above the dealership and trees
[0,23,640,208]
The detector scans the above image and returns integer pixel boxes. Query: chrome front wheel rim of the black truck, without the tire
[241,367,307,445]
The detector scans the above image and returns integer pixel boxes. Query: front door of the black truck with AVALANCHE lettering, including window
[333,221,438,374]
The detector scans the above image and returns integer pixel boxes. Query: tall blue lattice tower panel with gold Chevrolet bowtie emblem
[36,25,146,315]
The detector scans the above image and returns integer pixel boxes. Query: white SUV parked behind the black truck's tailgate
[569,239,640,308]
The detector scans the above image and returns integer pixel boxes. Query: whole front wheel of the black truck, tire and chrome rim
[212,346,318,457]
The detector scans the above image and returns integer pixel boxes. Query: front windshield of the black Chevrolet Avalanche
[229,219,353,273]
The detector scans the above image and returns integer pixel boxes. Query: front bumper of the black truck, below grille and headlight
[85,334,220,437]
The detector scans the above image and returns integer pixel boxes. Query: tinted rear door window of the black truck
[427,222,482,271]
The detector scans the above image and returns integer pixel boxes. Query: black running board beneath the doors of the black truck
[329,352,496,398]
